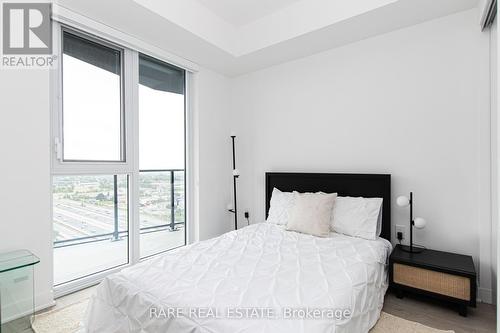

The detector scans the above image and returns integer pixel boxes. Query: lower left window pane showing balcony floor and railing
[53,175,129,285]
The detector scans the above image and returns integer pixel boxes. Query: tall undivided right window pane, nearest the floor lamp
[139,54,186,258]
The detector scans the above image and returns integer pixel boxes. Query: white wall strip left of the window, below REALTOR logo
[0,69,52,312]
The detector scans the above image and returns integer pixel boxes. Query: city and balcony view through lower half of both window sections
[53,171,185,285]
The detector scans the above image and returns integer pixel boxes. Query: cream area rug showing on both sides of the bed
[33,300,453,333]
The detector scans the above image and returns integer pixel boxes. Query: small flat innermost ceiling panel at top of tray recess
[196,0,300,27]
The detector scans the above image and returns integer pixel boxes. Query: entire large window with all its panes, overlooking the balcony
[52,24,187,293]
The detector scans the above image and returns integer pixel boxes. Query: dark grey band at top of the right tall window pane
[139,54,185,94]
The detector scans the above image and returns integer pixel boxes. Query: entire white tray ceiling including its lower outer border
[57,0,480,76]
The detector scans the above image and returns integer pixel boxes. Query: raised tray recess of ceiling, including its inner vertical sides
[134,0,477,57]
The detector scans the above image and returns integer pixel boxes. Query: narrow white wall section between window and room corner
[194,69,234,240]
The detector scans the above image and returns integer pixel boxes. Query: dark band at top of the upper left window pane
[63,31,121,75]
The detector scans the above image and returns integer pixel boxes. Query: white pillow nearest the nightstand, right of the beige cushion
[331,197,382,240]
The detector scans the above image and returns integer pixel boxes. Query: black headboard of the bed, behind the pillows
[266,172,391,241]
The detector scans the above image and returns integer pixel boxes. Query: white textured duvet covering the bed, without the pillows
[83,223,391,333]
